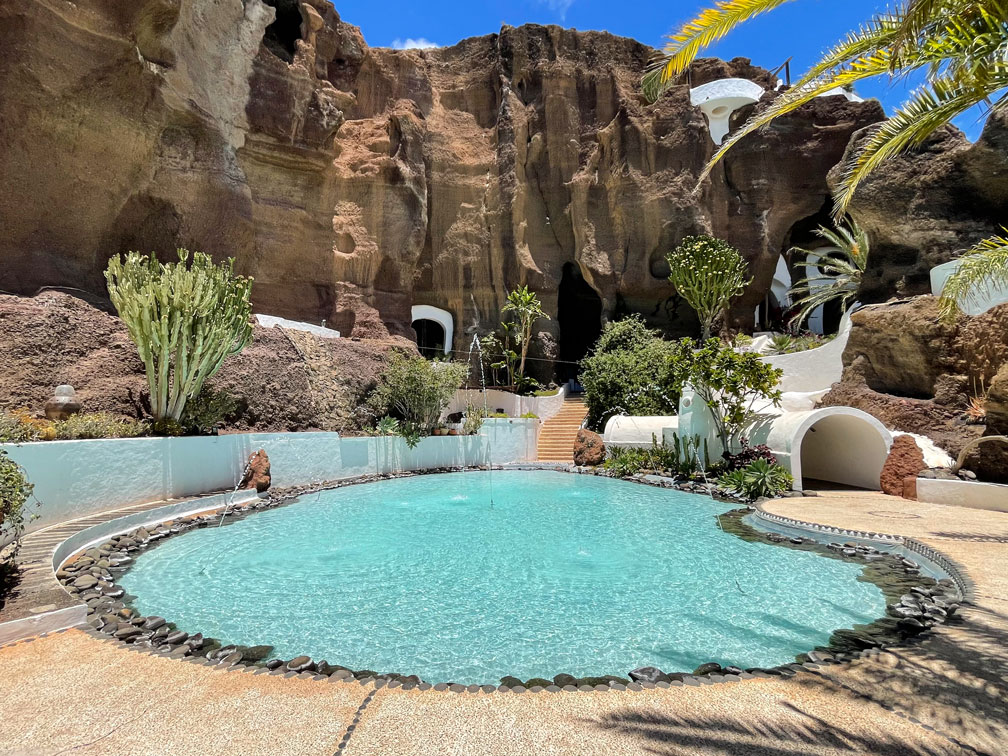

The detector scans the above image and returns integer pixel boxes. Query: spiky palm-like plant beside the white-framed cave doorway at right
[788,220,869,326]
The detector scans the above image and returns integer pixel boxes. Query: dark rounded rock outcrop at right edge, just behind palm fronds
[830,111,1008,302]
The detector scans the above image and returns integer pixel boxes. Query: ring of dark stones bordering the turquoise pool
[56,465,973,694]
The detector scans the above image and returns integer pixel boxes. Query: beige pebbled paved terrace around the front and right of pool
[0,492,1008,756]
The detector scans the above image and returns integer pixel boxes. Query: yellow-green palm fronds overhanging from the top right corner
[641,0,1008,217]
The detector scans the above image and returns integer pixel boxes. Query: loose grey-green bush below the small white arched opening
[368,352,469,436]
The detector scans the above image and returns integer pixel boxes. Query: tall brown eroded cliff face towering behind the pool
[0,0,882,364]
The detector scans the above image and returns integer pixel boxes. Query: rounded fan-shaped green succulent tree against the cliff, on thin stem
[666,236,752,339]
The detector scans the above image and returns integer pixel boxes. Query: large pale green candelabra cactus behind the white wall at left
[105,249,252,420]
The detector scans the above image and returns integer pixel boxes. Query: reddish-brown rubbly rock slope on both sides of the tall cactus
[0,291,415,431]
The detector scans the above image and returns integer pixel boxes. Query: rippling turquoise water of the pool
[119,471,885,684]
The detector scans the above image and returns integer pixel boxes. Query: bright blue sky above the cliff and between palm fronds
[335,0,982,139]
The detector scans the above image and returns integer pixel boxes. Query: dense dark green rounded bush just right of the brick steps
[579,316,691,429]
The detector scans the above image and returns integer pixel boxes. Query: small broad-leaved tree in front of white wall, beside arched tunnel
[680,339,783,450]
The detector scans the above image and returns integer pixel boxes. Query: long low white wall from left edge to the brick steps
[0,418,540,532]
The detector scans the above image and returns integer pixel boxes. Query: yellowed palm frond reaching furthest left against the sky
[641,0,791,102]
